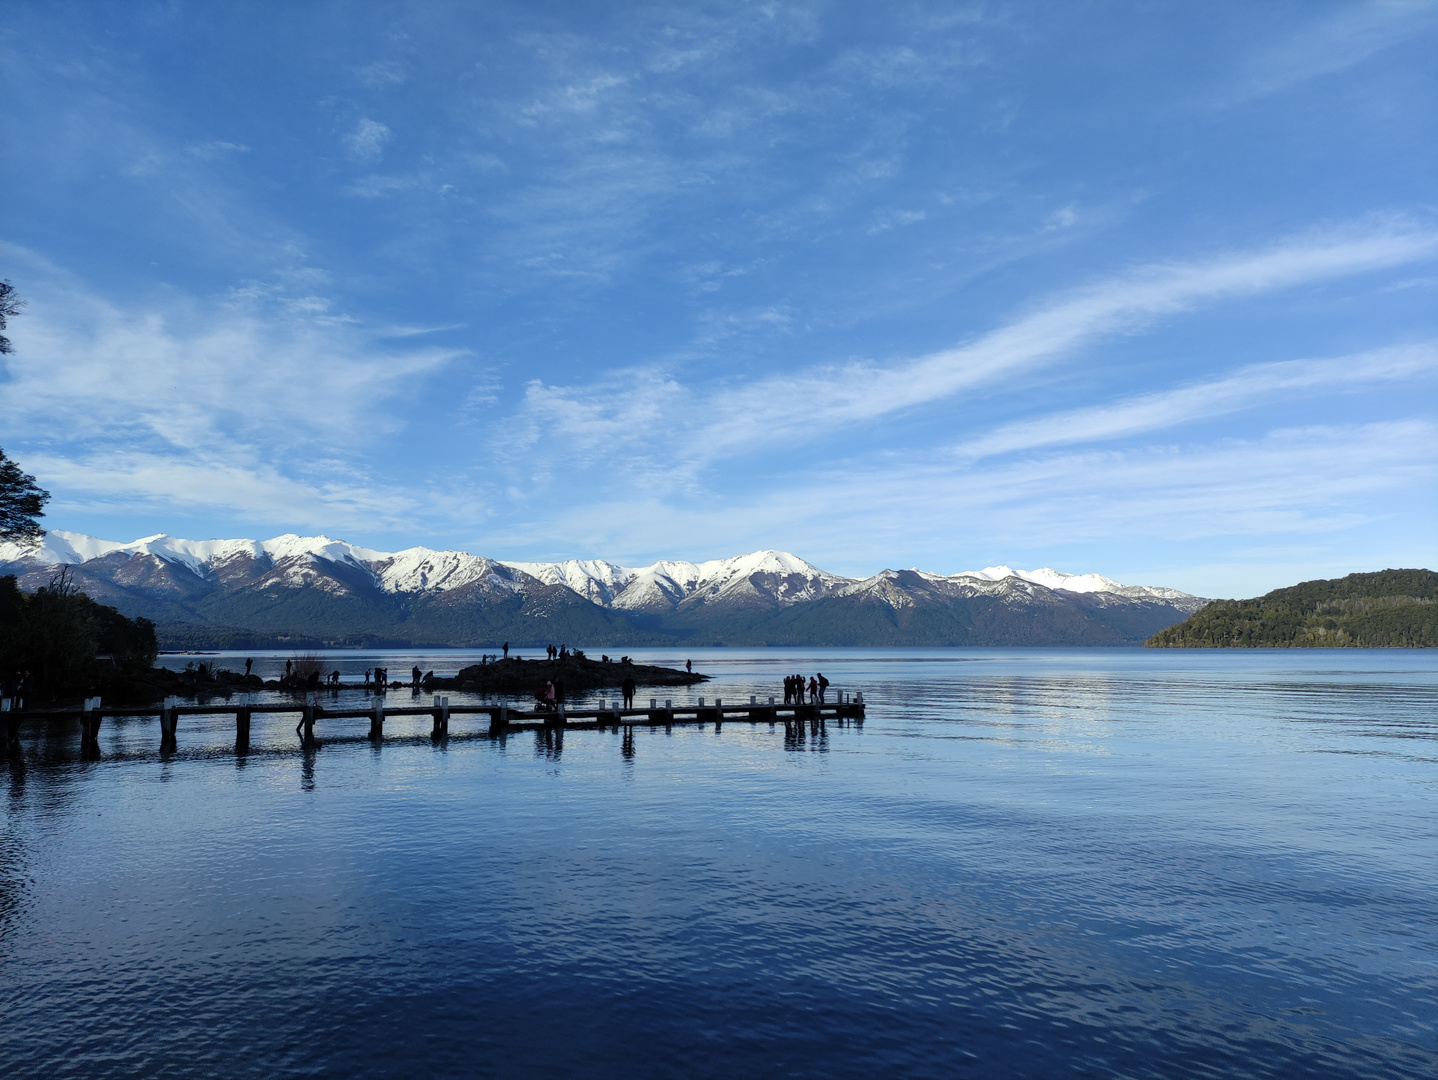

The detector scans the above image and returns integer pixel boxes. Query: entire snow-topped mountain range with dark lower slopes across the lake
[0,529,1206,647]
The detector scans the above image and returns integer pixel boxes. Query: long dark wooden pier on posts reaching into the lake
[0,693,864,754]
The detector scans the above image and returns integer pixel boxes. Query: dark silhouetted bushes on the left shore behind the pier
[0,572,158,702]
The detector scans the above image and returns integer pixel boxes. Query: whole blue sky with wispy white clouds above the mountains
[0,0,1438,595]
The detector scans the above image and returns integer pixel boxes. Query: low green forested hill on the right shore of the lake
[1145,569,1438,649]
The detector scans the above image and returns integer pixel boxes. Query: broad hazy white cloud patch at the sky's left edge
[0,249,462,525]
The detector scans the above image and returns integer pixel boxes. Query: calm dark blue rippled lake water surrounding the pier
[0,649,1438,1079]
